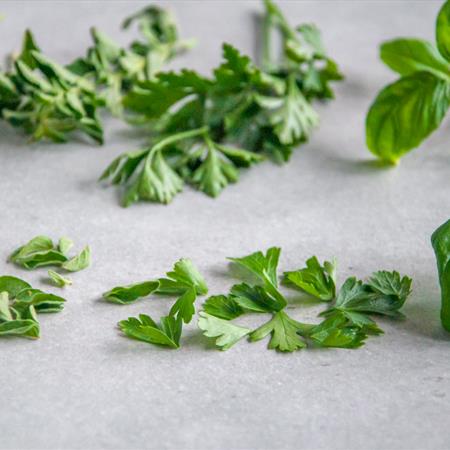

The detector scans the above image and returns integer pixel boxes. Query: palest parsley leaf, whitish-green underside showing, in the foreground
[198,311,251,350]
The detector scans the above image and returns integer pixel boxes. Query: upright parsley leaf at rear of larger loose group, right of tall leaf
[284,256,336,302]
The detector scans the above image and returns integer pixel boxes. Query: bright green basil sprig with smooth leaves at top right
[366,0,450,163]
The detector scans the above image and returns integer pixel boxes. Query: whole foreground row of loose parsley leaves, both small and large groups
[103,247,412,352]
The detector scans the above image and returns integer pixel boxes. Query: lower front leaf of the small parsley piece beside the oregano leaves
[119,314,182,348]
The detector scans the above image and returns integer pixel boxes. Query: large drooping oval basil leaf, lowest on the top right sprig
[366,72,450,163]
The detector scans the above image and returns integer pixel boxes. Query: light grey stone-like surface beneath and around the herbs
[0,1,450,449]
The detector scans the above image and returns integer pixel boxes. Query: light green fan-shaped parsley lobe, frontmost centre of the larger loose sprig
[250,311,306,352]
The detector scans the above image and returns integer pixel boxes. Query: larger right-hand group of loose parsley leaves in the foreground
[198,247,411,352]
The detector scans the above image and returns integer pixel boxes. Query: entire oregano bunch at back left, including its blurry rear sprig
[0,6,192,144]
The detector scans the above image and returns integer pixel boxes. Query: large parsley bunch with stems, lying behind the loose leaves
[101,0,342,206]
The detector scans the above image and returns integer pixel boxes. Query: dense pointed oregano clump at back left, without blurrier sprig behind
[0,30,103,143]
